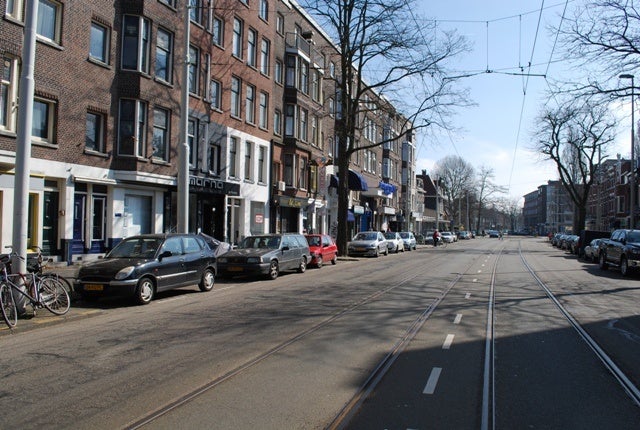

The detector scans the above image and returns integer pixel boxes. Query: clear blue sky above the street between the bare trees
[417,0,629,203]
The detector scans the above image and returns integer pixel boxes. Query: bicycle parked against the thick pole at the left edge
[0,247,71,328]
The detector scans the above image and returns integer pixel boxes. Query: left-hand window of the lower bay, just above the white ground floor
[118,99,147,157]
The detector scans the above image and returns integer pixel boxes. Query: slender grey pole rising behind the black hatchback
[177,0,191,233]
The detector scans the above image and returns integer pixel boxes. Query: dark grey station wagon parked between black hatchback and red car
[218,233,311,279]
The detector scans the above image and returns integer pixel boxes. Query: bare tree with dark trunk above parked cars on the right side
[536,98,616,233]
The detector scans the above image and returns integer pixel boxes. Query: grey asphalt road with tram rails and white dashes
[0,237,640,429]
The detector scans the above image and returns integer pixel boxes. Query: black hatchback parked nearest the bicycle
[75,234,217,305]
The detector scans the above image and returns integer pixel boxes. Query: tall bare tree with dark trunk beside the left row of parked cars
[301,0,467,253]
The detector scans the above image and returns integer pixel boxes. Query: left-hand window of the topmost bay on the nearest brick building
[121,15,149,73]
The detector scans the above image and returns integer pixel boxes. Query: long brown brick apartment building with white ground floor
[0,0,410,262]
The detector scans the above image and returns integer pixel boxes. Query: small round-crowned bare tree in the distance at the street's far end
[433,155,475,228]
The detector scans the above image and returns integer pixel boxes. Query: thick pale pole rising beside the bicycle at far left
[11,0,38,273]
